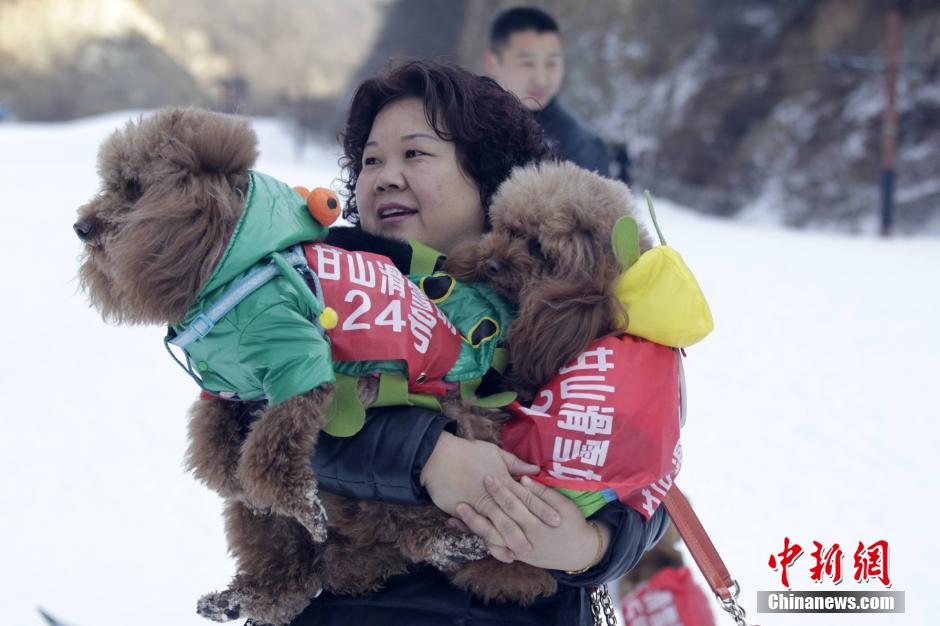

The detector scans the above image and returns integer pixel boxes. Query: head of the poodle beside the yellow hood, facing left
[447,163,649,390]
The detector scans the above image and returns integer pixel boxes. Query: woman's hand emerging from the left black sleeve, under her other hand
[421,432,561,524]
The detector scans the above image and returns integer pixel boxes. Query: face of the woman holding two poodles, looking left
[356,98,484,254]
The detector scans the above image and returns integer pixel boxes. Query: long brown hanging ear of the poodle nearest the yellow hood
[506,280,617,393]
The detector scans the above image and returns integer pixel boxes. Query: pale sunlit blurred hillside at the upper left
[0,0,383,120]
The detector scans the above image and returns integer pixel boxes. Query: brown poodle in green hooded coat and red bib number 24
[74,109,496,624]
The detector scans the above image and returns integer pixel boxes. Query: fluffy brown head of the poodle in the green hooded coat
[73,109,257,324]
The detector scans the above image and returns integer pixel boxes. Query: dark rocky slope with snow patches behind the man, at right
[462,0,940,232]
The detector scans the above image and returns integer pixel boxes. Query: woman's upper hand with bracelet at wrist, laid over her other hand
[449,476,611,571]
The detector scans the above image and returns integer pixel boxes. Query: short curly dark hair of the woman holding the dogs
[339,61,554,227]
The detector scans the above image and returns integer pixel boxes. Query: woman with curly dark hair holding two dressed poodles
[293,62,666,626]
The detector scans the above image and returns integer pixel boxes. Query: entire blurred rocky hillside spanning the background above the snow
[0,0,940,233]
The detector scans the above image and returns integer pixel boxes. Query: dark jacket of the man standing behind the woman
[535,98,610,176]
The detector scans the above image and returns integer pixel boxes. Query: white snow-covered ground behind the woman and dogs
[0,114,940,626]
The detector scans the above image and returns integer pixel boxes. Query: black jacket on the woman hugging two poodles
[302,407,668,626]
